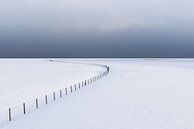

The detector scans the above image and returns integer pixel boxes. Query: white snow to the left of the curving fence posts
[0,59,104,127]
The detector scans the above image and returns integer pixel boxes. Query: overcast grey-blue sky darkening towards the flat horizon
[0,0,194,57]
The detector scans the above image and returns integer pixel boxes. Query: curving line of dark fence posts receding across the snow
[2,64,110,124]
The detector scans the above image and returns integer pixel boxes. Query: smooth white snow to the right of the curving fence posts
[1,59,194,129]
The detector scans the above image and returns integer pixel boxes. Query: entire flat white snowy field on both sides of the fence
[0,59,194,129]
